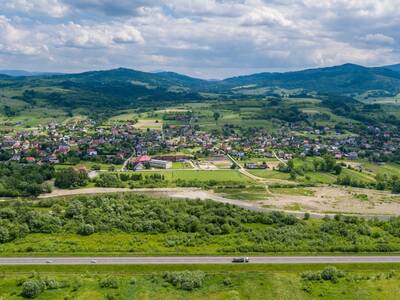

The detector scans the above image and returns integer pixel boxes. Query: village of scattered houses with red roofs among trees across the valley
[0,112,400,171]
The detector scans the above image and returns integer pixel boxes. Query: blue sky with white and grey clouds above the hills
[0,0,400,78]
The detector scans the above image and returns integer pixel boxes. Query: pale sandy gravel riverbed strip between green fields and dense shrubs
[39,186,400,216]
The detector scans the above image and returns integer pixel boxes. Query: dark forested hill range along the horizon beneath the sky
[0,64,400,111]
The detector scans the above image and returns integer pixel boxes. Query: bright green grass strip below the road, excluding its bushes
[0,264,400,300]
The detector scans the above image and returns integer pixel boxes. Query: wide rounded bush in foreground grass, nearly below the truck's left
[163,271,205,291]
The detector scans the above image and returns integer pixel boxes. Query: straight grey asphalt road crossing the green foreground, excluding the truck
[0,256,400,265]
